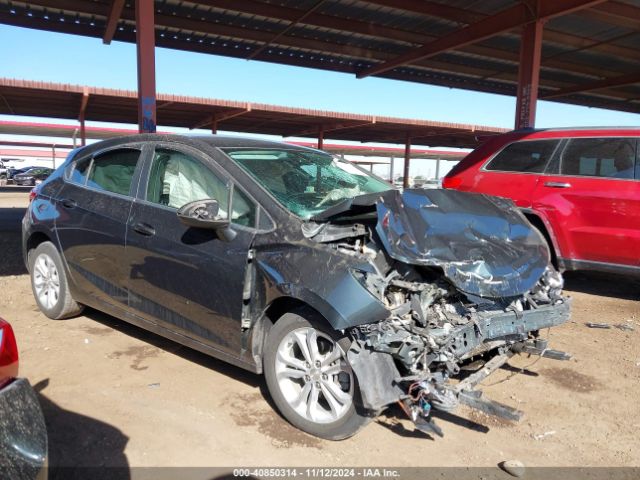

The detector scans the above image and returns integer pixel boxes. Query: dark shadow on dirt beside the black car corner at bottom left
[33,379,131,480]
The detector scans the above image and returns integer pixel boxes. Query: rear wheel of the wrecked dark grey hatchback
[29,242,84,320]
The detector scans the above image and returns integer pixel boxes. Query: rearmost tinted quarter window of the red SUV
[485,140,558,173]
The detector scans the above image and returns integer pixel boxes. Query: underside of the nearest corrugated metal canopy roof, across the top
[0,0,640,112]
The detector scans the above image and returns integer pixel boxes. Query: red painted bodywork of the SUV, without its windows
[443,128,640,271]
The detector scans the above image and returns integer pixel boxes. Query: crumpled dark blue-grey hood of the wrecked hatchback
[376,189,549,298]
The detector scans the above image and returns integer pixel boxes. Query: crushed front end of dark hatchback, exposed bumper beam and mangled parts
[348,269,570,435]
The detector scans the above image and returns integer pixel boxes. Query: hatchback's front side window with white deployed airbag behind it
[146,148,256,227]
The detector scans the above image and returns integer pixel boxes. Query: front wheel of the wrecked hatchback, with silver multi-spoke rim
[263,309,372,440]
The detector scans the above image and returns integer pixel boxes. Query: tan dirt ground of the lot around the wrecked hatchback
[0,192,640,478]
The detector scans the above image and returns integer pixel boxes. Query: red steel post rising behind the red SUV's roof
[515,20,544,129]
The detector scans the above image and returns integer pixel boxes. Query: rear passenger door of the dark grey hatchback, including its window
[56,145,141,307]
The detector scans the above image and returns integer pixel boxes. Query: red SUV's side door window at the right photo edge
[560,138,636,179]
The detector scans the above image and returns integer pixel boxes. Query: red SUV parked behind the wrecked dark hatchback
[443,128,640,273]
